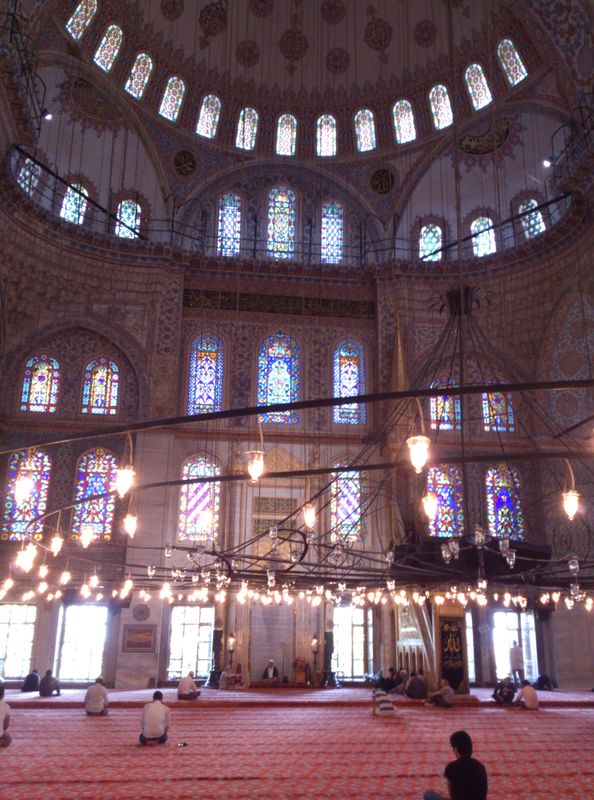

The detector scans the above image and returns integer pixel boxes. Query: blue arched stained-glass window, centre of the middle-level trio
[258,331,301,425]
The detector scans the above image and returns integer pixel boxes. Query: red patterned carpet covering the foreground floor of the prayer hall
[0,694,594,800]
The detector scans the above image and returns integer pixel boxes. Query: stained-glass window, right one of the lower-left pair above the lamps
[72,447,118,541]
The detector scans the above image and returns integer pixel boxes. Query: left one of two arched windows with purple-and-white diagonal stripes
[177,456,221,544]
